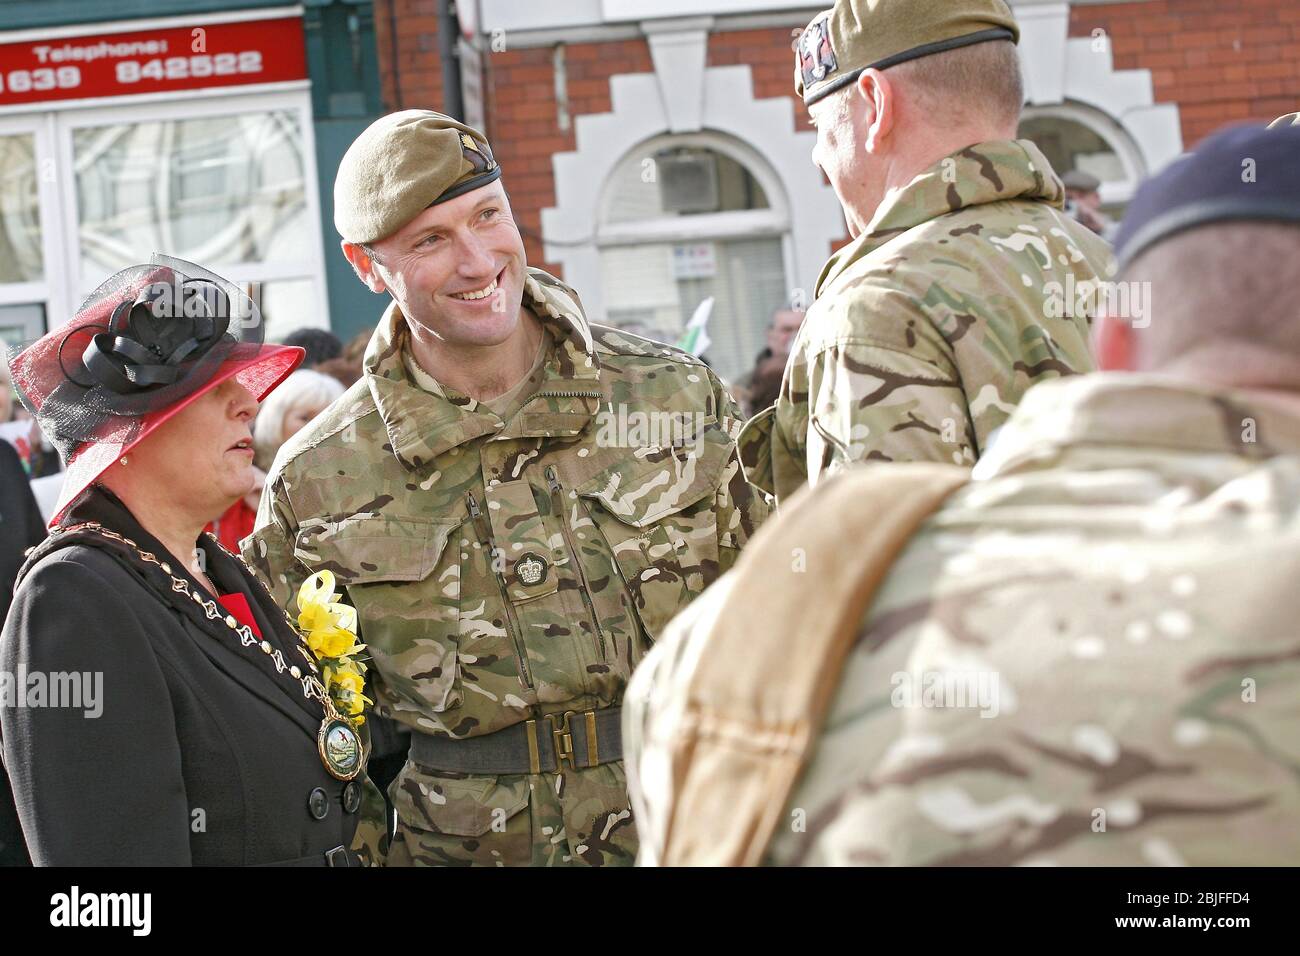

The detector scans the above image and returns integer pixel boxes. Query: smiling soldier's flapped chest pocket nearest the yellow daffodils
[294,515,462,713]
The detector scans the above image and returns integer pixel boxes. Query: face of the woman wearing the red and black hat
[122,378,257,520]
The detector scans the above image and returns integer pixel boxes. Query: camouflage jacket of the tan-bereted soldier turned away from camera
[740,140,1112,499]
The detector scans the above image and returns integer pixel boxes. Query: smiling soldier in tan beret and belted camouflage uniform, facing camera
[244,111,766,865]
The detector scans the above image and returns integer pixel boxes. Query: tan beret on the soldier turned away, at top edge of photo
[794,0,1021,105]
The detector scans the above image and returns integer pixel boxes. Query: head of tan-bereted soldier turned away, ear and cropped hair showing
[794,0,1024,235]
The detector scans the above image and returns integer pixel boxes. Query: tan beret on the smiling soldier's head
[334,109,501,242]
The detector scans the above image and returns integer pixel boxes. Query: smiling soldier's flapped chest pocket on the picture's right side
[579,424,732,640]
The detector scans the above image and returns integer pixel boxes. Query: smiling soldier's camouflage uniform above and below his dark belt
[243,269,766,865]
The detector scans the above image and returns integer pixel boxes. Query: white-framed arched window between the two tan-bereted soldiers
[595,134,790,381]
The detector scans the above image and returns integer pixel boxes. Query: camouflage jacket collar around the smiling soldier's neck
[363,269,601,470]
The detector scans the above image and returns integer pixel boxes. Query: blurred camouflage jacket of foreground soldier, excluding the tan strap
[624,375,1300,866]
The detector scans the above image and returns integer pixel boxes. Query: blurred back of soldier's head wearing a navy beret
[1096,126,1300,392]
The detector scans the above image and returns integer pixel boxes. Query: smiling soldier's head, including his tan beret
[334,109,528,356]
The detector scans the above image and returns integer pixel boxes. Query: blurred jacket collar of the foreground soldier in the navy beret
[975,372,1300,479]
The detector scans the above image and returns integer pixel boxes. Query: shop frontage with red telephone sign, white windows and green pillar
[0,0,382,346]
